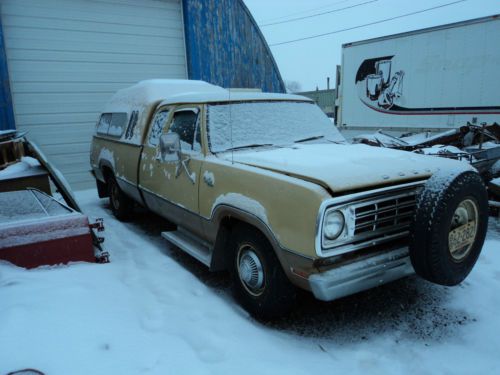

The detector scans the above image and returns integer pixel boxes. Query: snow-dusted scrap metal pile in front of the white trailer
[352,123,500,212]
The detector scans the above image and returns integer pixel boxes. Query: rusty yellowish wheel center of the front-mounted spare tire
[448,199,478,262]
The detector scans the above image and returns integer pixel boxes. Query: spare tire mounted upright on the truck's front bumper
[409,170,488,286]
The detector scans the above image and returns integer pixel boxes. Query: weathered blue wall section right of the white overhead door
[183,0,285,92]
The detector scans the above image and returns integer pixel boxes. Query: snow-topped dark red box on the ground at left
[0,189,95,268]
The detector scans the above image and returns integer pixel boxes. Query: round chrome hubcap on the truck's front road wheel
[238,245,264,296]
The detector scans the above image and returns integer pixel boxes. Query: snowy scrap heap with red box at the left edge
[0,131,109,268]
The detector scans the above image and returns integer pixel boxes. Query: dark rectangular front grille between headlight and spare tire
[354,189,417,236]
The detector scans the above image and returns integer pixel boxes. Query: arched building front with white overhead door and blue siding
[0,0,285,189]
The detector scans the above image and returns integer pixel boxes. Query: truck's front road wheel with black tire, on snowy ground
[230,227,296,320]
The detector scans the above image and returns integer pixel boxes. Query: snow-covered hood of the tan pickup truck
[226,144,465,193]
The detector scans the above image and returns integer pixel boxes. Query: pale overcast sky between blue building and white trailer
[244,0,500,91]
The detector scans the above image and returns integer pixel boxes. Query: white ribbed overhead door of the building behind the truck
[0,0,187,189]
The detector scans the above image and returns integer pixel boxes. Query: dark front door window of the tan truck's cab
[168,109,201,152]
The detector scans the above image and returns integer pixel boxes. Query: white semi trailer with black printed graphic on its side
[336,15,500,137]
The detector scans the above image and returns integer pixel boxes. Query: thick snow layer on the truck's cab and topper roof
[104,79,312,112]
